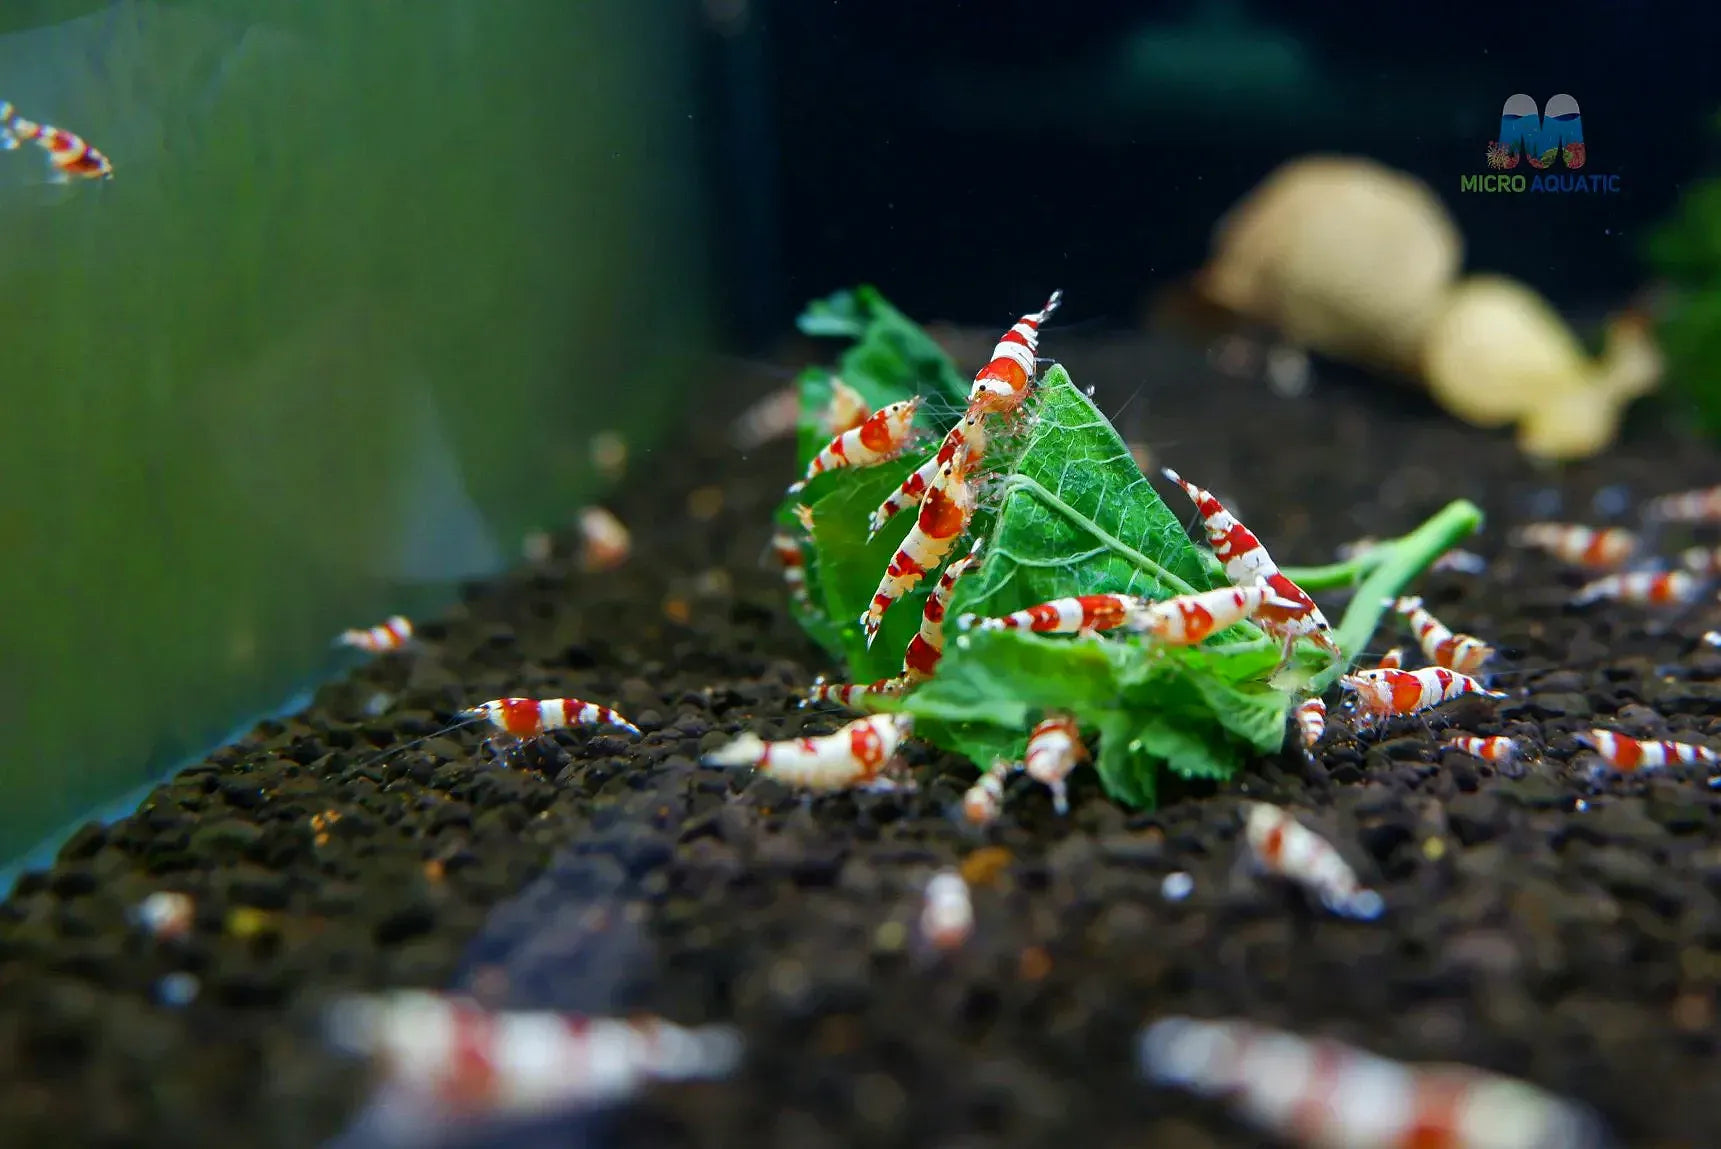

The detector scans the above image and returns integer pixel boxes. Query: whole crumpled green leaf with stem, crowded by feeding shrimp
[778,287,1480,805]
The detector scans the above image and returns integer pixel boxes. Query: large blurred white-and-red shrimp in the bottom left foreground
[325,991,742,1121]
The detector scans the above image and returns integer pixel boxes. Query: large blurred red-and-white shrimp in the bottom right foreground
[1138,1017,1613,1149]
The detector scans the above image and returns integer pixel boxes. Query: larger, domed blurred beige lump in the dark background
[1196,157,1465,373]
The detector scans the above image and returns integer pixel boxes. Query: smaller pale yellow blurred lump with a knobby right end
[1422,275,1661,459]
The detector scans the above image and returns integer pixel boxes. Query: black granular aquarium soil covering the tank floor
[0,335,1721,1149]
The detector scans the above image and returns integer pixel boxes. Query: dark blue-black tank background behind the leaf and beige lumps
[700,0,1721,349]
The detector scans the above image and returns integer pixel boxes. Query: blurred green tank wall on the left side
[0,0,704,860]
